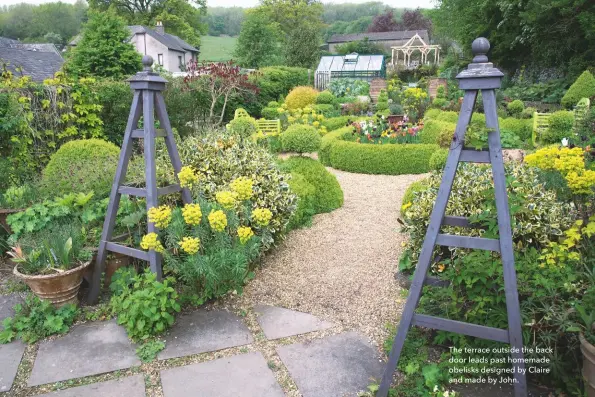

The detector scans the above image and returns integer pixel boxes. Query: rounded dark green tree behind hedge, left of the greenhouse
[234,10,281,68]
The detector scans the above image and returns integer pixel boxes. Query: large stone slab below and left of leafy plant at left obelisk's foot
[28,320,140,386]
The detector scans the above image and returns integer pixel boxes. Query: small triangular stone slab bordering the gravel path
[254,305,333,340]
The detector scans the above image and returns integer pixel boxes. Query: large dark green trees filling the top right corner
[432,0,595,79]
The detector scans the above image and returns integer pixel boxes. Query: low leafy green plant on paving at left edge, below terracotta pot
[0,295,78,343]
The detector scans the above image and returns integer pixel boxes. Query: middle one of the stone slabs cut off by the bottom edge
[161,352,284,397]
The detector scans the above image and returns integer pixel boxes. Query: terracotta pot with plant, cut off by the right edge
[568,305,595,397]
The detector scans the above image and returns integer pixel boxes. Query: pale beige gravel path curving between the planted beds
[229,169,424,346]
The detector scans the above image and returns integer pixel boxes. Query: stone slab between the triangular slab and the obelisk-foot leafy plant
[158,309,254,360]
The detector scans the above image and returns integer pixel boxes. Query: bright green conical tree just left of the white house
[65,8,141,79]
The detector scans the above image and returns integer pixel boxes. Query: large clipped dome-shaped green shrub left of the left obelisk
[41,139,120,197]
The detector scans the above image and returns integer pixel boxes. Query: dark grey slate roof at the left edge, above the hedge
[0,43,64,81]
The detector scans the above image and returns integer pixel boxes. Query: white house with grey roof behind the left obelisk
[69,22,200,73]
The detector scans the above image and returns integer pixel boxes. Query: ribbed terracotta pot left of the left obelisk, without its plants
[13,262,91,307]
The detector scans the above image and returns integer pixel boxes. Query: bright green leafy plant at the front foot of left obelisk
[110,268,180,341]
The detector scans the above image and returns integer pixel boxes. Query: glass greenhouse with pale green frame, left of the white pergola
[314,53,386,90]
